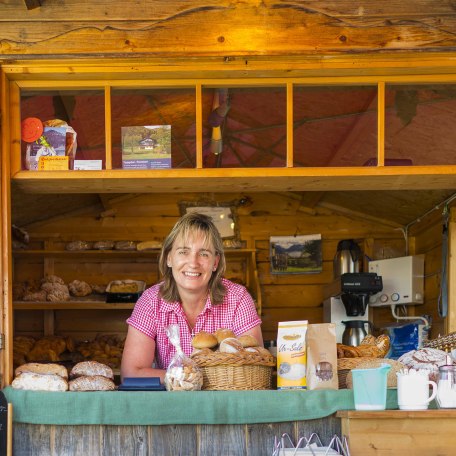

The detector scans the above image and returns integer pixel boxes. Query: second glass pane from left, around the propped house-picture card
[111,88,196,169]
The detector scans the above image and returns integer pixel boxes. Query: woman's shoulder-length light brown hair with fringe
[158,212,226,305]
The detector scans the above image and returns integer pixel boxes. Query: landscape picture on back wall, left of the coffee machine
[269,234,322,274]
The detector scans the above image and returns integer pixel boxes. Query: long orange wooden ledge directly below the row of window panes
[12,165,456,193]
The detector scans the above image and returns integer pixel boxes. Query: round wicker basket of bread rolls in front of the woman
[191,328,275,390]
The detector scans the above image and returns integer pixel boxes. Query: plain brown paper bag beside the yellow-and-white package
[306,323,339,390]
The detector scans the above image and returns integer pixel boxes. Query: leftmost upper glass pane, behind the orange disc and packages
[21,90,106,169]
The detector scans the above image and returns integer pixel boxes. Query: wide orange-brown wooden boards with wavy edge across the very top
[0,0,456,59]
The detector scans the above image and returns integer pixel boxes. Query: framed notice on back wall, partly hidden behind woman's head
[179,201,240,240]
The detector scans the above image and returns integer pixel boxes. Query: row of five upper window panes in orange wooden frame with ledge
[7,68,456,193]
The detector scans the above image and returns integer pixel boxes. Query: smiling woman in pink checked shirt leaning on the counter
[121,212,263,381]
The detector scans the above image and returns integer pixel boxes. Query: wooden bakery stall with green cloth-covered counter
[0,0,456,455]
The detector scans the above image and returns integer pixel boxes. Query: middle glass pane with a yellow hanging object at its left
[203,87,287,168]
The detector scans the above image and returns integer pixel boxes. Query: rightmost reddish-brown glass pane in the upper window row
[385,84,456,165]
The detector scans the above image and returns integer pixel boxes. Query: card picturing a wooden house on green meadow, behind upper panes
[121,125,171,169]
